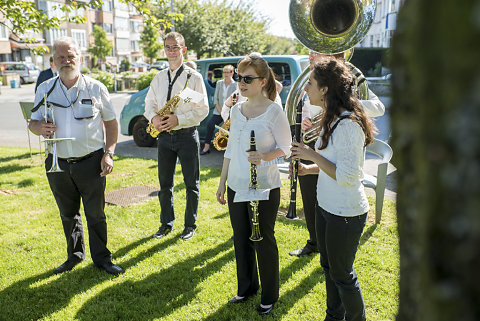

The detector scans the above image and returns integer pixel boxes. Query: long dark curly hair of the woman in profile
[312,57,376,149]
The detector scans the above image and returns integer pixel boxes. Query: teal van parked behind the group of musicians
[120,55,308,147]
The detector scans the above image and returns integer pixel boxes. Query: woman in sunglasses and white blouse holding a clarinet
[217,55,291,314]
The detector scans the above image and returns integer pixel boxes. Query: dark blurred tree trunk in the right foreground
[391,0,480,321]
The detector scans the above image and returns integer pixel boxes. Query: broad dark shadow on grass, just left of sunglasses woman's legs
[75,240,234,320]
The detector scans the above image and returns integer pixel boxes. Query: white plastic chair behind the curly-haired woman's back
[362,139,393,224]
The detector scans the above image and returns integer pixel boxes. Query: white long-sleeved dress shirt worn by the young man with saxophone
[144,66,209,130]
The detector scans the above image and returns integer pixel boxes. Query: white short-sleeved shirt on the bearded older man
[32,75,116,158]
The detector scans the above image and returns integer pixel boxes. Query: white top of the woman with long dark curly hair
[315,113,369,216]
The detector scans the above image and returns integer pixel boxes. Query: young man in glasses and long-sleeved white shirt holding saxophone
[144,32,209,240]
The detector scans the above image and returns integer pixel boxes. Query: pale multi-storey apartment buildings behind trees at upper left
[0,0,144,68]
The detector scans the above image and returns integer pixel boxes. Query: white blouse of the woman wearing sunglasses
[224,103,292,202]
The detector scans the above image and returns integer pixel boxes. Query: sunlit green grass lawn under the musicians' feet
[0,147,399,321]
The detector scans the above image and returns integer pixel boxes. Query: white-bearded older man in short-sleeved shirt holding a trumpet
[29,37,123,275]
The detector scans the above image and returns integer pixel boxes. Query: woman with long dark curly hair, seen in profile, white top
[292,57,375,321]
